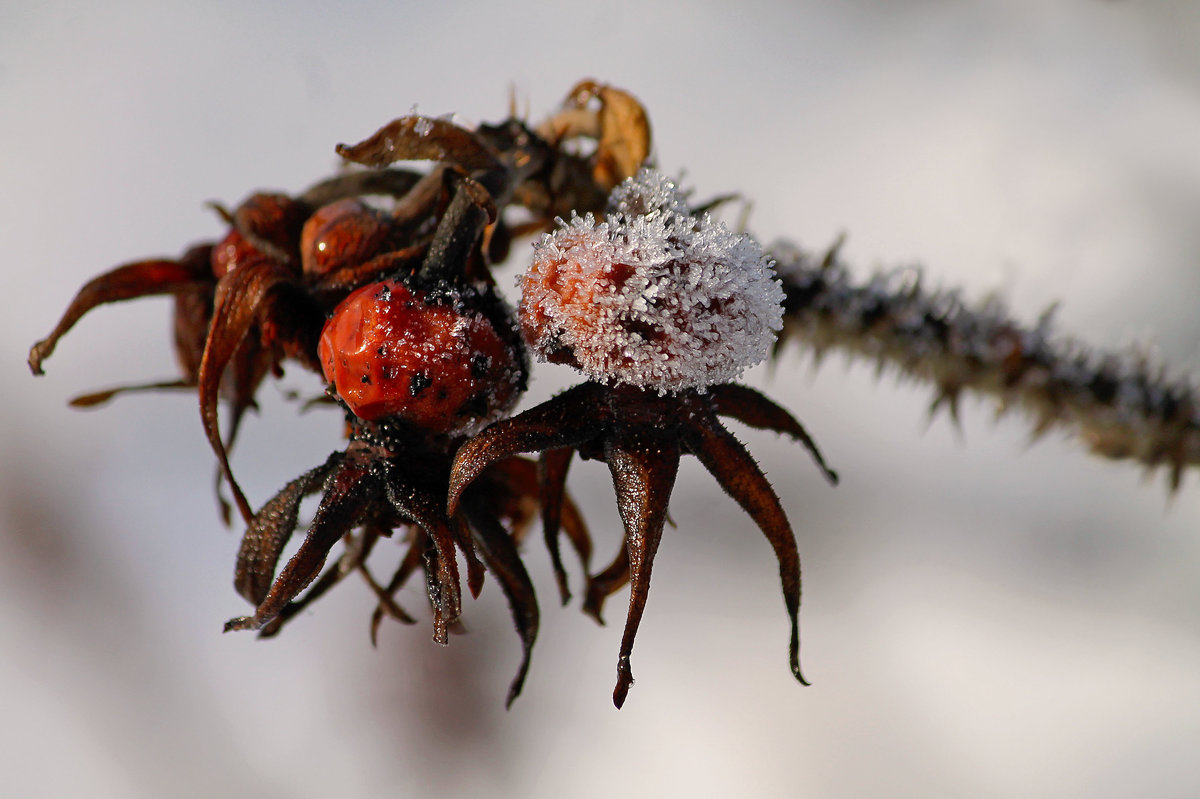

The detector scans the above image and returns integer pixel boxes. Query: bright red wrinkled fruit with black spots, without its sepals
[317,281,526,433]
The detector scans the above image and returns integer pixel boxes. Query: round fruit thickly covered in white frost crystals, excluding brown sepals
[520,169,784,394]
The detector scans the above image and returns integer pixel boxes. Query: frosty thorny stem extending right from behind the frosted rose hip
[772,241,1200,491]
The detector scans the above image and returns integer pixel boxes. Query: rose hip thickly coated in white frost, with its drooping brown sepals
[458,169,838,708]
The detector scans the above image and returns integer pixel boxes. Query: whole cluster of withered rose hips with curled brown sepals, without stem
[30,82,836,707]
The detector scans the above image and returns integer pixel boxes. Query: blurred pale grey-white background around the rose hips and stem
[0,0,1200,798]
